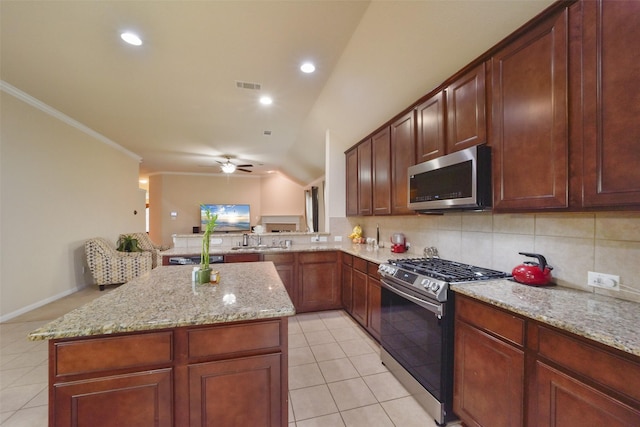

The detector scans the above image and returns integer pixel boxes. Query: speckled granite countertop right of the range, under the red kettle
[451,280,640,356]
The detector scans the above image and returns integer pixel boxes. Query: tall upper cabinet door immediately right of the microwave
[491,9,568,211]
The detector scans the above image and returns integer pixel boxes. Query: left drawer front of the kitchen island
[53,332,173,376]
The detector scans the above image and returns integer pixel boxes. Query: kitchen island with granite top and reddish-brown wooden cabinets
[30,262,295,426]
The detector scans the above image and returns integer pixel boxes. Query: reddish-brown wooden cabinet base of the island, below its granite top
[49,318,288,427]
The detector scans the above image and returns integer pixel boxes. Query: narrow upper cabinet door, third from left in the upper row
[371,127,391,215]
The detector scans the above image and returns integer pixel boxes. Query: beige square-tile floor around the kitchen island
[0,289,458,427]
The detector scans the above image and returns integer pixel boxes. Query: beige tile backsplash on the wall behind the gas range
[330,212,640,302]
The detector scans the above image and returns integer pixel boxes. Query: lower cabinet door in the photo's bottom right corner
[532,362,640,427]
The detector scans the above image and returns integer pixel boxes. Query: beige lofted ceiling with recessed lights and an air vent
[0,0,550,184]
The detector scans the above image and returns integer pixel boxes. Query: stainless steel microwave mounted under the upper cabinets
[408,145,492,212]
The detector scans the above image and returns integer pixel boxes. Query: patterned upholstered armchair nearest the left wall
[85,237,153,291]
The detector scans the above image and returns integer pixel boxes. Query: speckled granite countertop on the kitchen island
[29,262,295,340]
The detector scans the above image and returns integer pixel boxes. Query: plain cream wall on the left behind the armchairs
[0,85,145,321]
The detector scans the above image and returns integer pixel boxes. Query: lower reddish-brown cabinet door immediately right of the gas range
[453,320,524,427]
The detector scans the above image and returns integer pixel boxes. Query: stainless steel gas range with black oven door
[378,257,508,425]
